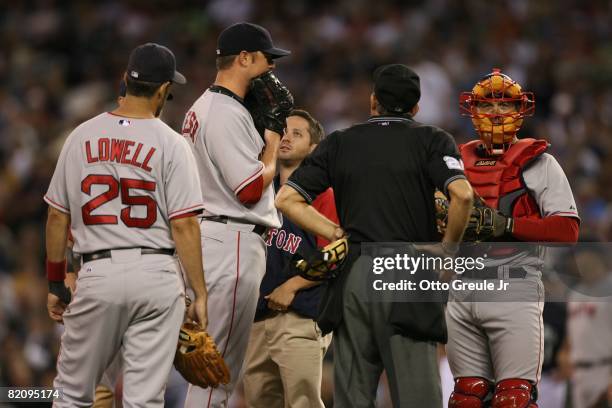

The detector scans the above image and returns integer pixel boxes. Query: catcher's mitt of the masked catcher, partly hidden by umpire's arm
[434,194,512,242]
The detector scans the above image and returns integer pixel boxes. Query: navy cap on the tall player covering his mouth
[217,23,291,58]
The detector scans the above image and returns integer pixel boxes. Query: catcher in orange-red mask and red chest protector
[446,69,579,407]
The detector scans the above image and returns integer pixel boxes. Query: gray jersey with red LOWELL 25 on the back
[44,113,203,253]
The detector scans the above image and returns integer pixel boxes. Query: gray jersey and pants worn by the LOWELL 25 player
[45,113,203,408]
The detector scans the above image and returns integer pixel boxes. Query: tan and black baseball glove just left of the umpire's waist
[294,238,348,281]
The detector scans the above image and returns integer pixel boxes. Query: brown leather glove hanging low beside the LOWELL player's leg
[174,323,230,388]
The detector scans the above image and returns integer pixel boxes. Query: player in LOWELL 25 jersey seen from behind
[44,43,207,407]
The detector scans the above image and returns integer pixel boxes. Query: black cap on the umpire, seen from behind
[374,64,421,114]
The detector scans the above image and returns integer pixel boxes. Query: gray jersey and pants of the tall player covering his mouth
[183,90,281,408]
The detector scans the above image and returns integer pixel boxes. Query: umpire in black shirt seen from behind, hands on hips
[276,64,472,408]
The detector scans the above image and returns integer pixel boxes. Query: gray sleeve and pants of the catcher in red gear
[446,153,579,382]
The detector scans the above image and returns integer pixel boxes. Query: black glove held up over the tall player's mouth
[245,71,293,136]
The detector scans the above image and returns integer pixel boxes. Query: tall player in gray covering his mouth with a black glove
[183,23,289,408]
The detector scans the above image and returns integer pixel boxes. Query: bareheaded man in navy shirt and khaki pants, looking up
[244,110,338,408]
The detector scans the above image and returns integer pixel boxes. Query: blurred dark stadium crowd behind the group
[0,0,612,406]
